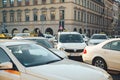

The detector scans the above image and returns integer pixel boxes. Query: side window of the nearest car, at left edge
[0,48,10,63]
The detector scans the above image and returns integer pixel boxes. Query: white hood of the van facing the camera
[59,42,86,49]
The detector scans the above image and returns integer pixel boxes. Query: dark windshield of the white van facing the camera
[60,34,84,43]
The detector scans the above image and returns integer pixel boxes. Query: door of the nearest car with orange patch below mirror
[0,47,20,80]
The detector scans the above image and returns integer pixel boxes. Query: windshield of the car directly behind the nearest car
[26,39,53,48]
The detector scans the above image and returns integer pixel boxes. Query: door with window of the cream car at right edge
[106,40,120,71]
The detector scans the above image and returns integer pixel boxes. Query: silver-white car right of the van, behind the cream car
[88,34,109,45]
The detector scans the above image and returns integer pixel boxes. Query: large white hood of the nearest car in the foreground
[26,59,109,80]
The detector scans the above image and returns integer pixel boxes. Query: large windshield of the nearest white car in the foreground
[8,44,61,67]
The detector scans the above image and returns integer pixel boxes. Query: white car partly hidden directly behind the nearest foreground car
[12,37,68,58]
